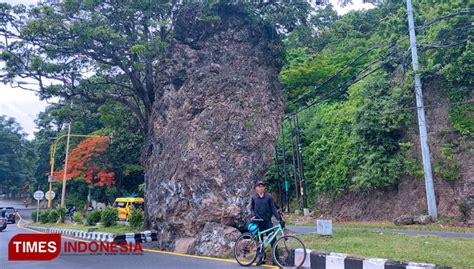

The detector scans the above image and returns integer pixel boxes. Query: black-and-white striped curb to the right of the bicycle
[295,249,442,269]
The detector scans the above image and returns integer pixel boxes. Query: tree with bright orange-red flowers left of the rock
[54,137,115,187]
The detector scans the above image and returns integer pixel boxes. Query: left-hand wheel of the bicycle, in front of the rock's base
[234,230,258,266]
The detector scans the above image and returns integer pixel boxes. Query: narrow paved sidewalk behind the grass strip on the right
[288,226,474,239]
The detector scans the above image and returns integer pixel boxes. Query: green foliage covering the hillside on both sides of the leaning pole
[266,0,474,199]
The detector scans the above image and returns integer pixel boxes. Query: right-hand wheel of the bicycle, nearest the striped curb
[273,235,306,268]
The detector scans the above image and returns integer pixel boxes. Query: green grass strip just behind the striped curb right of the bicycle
[299,230,474,268]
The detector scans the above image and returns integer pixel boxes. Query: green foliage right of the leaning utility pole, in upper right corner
[419,0,474,138]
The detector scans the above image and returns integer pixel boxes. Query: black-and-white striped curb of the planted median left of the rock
[23,224,158,244]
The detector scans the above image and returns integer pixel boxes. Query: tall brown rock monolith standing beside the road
[145,6,284,250]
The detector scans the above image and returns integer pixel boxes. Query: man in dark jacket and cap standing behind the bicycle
[250,180,281,266]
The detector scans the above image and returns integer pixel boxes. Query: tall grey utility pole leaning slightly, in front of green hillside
[406,0,438,220]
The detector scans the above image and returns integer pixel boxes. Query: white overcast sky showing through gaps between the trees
[0,0,371,139]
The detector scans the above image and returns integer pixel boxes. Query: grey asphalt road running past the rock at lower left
[0,200,276,269]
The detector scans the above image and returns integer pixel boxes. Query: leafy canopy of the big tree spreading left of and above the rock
[0,0,324,133]
